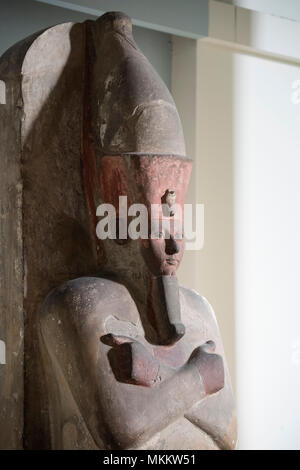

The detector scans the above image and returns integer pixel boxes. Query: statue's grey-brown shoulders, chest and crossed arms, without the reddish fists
[41,277,236,449]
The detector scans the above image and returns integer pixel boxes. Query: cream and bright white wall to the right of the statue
[176,40,300,449]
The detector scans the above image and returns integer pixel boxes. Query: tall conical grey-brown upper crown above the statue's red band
[87,13,185,156]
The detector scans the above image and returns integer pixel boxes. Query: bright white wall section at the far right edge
[233,49,300,449]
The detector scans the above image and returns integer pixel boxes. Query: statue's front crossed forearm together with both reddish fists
[102,335,224,448]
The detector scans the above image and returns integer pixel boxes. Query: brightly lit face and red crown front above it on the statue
[136,156,191,276]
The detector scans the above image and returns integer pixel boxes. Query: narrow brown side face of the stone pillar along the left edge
[0,31,41,449]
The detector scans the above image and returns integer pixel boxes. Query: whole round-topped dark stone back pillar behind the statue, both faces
[0,23,97,449]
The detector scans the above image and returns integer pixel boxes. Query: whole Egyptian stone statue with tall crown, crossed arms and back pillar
[0,13,236,449]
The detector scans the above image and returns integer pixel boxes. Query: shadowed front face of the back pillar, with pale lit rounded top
[22,24,96,448]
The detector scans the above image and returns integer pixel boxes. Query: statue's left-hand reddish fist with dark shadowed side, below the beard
[101,334,159,387]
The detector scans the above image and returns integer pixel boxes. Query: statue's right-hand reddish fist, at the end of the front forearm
[189,341,224,395]
